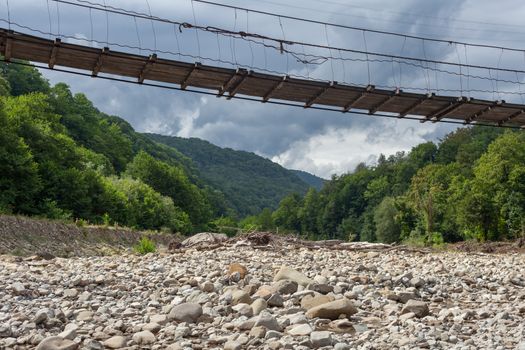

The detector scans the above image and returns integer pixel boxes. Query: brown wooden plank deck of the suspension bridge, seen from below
[0,29,525,127]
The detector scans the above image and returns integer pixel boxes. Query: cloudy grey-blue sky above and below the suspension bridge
[4,0,525,178]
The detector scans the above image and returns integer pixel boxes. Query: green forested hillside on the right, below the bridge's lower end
[245,127,525,244]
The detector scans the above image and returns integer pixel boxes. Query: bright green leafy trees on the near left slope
[0,64,220,233]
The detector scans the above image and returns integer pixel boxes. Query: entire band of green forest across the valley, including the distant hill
[0,60,525,244]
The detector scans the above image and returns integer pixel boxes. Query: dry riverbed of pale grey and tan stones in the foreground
[0,234,525,350]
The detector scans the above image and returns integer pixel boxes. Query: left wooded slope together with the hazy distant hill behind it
[0,60,324,233]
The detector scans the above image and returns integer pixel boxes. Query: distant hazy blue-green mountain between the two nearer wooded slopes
[145,134,314,216]
